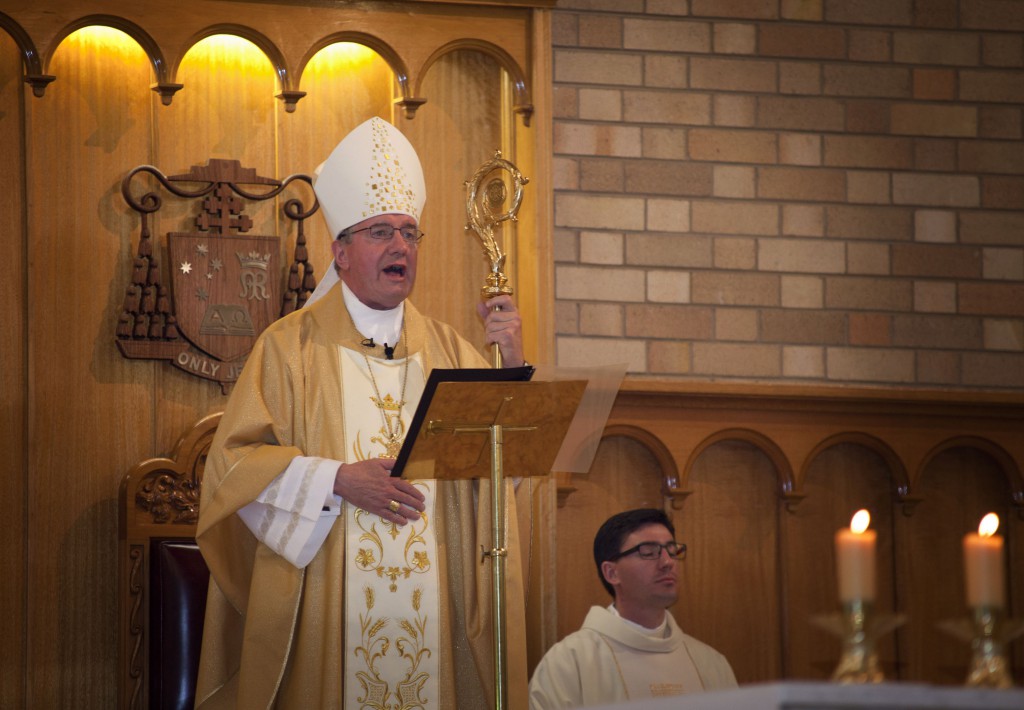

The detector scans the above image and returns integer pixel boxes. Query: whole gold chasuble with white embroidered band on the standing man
[197,287,529,710]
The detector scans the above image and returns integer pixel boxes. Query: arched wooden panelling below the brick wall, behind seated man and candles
[556,381,1024,684]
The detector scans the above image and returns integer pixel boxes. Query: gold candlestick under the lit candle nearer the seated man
[814,599,906,683]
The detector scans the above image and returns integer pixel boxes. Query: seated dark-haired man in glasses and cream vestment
[529,508,736,710]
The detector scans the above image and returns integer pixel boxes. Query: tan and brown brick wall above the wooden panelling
[552,0,1024,389]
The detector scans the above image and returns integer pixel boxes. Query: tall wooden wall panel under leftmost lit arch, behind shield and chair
[20,29,156,707]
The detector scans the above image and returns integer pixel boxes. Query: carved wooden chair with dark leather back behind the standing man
[118,413,220,710]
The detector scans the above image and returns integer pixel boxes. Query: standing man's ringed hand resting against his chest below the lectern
[334,459,424,526]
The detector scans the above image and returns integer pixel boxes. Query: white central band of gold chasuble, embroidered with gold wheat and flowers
[340,348,440,710]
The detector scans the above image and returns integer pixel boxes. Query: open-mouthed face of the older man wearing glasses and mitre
[331,214,419,310]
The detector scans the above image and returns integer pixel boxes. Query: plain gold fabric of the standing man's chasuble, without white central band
[196,286,530,710]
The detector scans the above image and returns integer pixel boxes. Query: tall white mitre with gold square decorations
[306,117,427,305]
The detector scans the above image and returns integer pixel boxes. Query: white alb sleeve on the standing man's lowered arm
[239,456,341,569]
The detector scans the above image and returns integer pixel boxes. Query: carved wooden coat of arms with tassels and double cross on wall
[117,159,318,393]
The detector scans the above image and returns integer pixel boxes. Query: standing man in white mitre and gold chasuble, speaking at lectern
[197,118,528,710]
